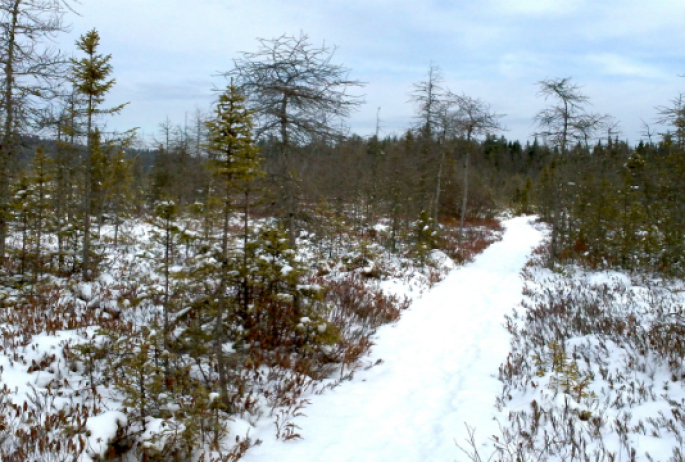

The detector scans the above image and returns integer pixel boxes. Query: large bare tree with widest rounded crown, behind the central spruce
[225,33,362,244]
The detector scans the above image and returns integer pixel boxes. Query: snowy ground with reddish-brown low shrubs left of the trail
[0,215,501,462]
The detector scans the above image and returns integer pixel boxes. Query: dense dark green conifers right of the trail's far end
[536,134,685,276]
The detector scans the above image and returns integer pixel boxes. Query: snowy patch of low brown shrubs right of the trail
[459,242,685,462]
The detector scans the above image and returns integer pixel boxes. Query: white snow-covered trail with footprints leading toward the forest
[244,217,541,462]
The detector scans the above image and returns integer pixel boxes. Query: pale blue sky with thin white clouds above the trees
[59,0,685,146]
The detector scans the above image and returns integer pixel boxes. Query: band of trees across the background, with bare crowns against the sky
[0,19,685,271]
